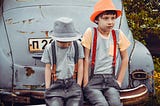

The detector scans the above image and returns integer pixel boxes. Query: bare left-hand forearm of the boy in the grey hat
[45,64,51,89]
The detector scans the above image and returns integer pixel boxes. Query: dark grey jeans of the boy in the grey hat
[44,78,83,106]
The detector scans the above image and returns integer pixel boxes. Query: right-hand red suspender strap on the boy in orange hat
[112,29,117,75]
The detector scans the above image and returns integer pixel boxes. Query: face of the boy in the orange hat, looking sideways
[97,14,116,32]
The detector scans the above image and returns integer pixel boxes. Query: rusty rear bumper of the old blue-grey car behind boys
[0,84,149,106]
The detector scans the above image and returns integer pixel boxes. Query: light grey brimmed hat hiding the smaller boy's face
[50,17,82,42]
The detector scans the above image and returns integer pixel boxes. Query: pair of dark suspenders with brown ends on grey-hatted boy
[51,41,79,81]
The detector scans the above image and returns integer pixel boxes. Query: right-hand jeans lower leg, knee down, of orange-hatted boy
[104,87,123,106]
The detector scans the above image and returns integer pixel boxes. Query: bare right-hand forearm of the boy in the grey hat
[77,59,83,86]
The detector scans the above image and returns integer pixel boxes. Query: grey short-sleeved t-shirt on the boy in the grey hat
[41,41,84,79]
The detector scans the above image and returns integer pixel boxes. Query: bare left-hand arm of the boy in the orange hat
[83,47,90,87]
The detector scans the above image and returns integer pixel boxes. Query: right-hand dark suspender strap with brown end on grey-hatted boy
[73,41,79,79]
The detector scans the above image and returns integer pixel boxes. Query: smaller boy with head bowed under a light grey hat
[41,17,84,106]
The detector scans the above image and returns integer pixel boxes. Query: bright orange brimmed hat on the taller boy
[90,0,121,22]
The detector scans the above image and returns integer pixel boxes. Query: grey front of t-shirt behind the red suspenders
[90,31,119,74]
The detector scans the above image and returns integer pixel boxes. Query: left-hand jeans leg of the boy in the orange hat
[84,75,109,106]
